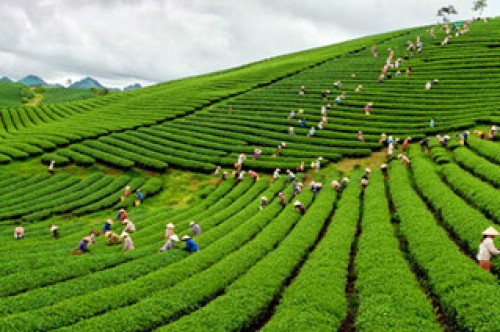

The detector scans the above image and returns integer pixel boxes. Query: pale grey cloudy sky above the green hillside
[0,0,500,87]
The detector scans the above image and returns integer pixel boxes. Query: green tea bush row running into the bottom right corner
[389,162,500,331]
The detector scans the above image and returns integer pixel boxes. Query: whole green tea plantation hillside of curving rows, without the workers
[0,20,500,331]
